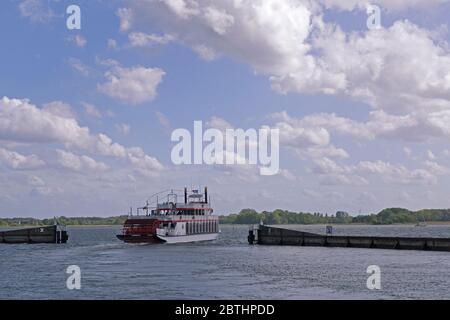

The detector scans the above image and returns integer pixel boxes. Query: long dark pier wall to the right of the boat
[249,225,450,251]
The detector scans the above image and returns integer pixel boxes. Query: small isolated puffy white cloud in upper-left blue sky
[97,66,165,105]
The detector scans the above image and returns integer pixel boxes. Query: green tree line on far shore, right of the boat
[216,208,450,225]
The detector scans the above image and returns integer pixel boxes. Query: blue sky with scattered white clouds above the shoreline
[0,0,450,218]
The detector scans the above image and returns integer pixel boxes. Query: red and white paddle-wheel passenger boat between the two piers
[117,188,219,243]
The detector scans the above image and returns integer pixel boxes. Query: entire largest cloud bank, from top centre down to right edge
[122,0,450,113]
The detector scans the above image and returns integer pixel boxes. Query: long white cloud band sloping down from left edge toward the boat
[0,97,164,174]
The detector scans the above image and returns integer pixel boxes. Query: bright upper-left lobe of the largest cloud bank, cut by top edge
[125,0,311,71]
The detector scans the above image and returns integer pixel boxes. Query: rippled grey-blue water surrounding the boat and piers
[0,226,450,299]
